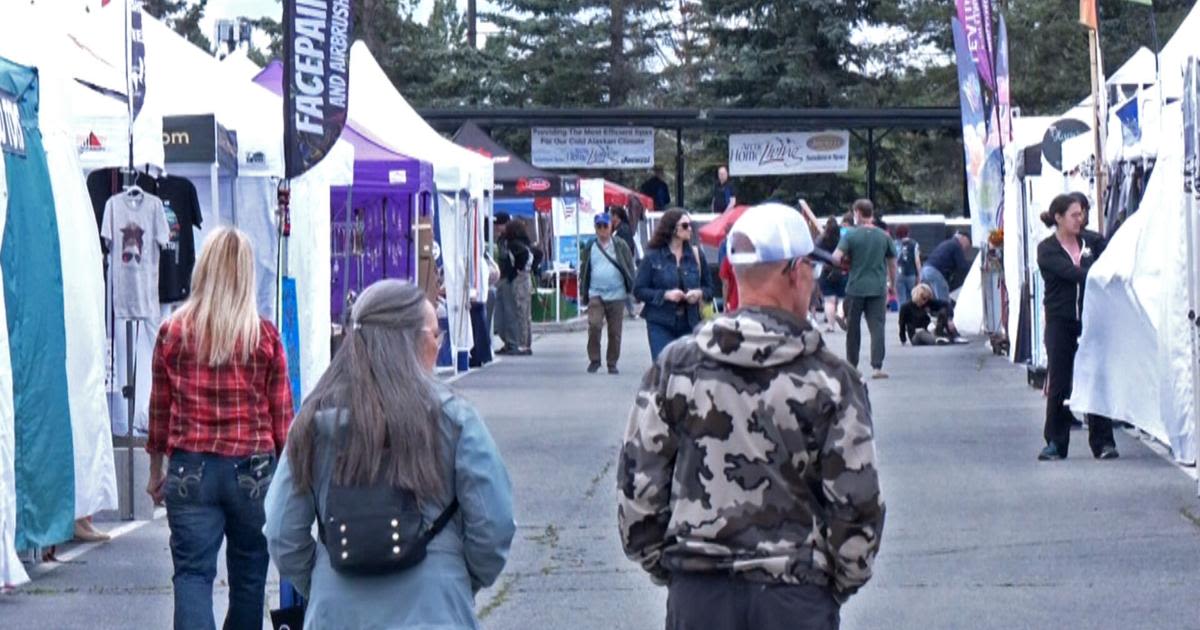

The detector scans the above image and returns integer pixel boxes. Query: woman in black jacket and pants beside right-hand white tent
[1038,194,1118,461]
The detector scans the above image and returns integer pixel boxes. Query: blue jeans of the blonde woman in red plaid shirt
[163,451,276,630]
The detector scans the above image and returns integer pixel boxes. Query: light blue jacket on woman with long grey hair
[263,390,516,630]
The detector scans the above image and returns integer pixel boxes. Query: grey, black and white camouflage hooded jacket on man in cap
[617,308,884,601]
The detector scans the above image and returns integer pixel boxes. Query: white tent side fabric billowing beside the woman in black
[1070,103,1196,462]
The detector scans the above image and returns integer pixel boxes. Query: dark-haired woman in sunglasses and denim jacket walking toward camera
[634,208,713,361]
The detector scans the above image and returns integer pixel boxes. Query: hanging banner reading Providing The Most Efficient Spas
[532,127,654,169]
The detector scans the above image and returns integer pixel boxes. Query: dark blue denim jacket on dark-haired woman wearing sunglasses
[634,246,713,326]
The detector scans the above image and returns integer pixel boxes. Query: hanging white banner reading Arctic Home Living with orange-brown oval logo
[730,131,850,176]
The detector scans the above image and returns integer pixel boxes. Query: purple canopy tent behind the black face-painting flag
[254,61,434,322]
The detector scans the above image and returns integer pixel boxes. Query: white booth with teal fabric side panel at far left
[0,2,162,586]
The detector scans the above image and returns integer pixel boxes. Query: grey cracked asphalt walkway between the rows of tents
[0,319,1200,630]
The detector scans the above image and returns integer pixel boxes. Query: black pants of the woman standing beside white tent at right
[1043,319,1116,457]
